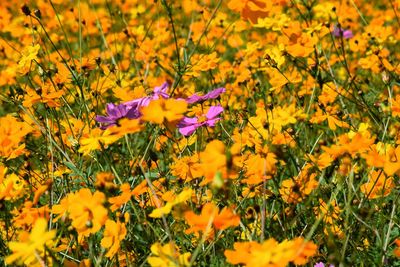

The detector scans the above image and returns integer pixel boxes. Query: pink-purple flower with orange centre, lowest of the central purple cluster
[178,106,224,136]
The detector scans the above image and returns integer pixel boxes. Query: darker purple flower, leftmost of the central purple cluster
[96,103,140,130]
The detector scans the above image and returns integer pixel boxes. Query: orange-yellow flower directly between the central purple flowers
[142,99,187,124]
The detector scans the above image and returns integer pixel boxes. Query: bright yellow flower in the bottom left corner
[6,218,56,266]
